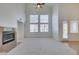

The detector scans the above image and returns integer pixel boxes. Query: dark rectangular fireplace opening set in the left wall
[2,31,15,45]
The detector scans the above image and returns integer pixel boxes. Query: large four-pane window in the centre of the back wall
[30,15,48,32]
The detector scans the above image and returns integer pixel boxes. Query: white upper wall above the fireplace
[0,3,25,27]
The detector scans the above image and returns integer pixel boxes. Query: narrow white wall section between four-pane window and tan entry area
[52,4,59,40]
